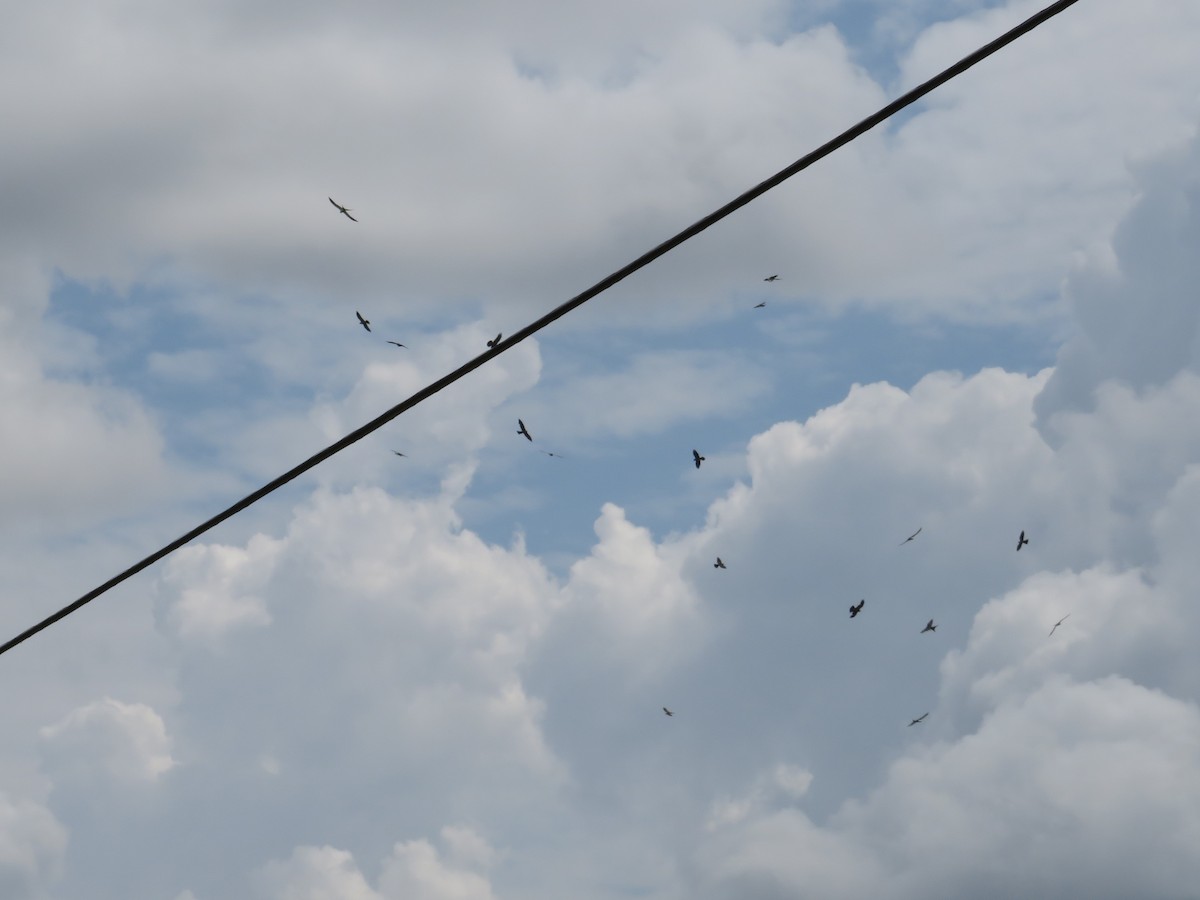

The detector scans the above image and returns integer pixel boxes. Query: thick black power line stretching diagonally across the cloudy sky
[0,0,1078,654]
